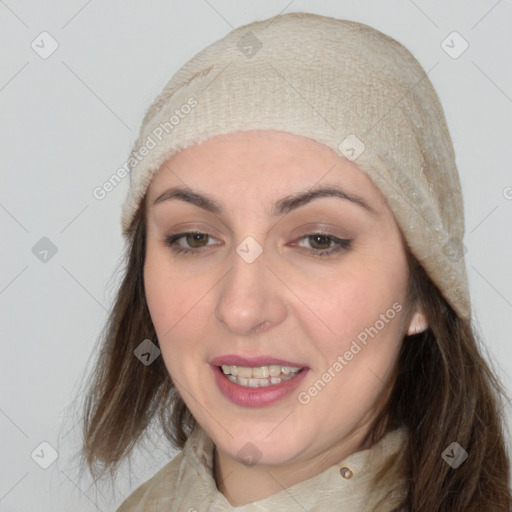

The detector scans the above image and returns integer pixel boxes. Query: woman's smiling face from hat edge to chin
[144,131,423,465]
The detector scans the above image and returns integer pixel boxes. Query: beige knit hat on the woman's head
[122,13,471,318]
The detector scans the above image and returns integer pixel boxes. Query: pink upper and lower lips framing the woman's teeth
[210,355,309,407]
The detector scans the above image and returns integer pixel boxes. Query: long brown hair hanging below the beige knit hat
[80,194,511,512]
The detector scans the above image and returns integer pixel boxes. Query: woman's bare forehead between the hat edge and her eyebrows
[148,131,385,209]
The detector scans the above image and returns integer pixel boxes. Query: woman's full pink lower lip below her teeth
[212,366,309,407]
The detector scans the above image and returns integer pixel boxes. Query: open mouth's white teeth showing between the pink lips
[219,364,304,388]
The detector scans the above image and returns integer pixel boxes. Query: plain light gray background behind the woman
[0,0,512,512]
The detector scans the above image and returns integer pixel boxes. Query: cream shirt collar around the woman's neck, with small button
[176,424,407,512]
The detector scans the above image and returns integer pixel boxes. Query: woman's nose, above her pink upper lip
[215,246,286,336]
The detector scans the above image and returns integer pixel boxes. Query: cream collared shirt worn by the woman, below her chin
[117,425,407,512]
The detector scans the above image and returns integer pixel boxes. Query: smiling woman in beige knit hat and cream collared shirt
[78,13,511,512]
